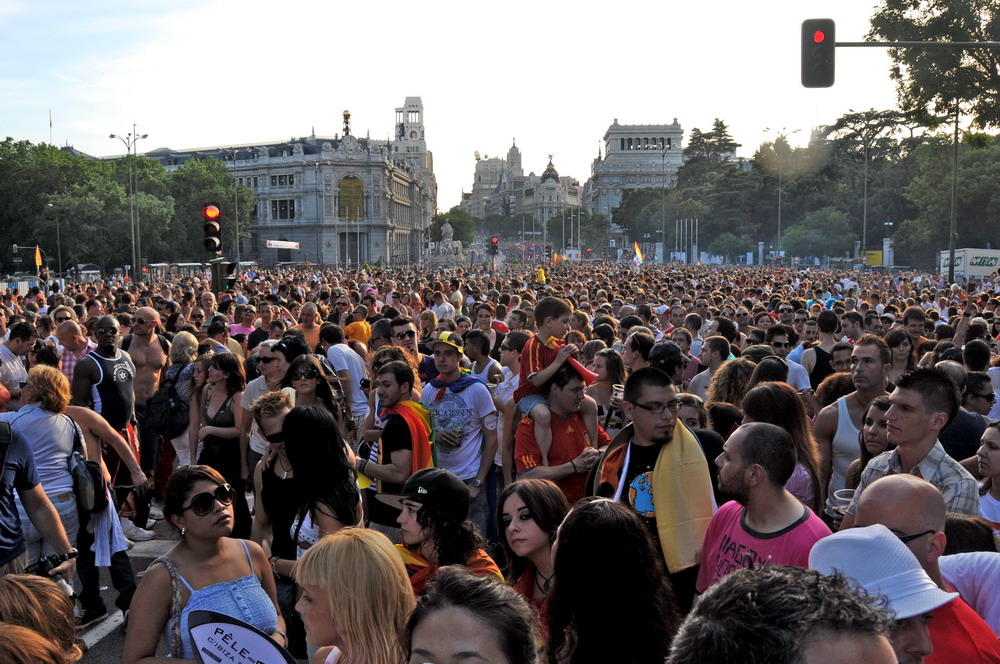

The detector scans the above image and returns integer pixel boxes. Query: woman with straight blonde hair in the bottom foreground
[294,528,415,664]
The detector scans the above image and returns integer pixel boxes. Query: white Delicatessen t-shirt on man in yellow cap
[420,382,497,481]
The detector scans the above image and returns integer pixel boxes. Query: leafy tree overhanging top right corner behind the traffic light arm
[868,0,1000,127]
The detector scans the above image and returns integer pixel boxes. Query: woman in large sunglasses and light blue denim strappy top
[122,466,287,664]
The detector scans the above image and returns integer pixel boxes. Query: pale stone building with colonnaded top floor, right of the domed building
[585,118,684,216]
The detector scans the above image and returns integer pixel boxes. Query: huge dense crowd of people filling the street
[0,262,1000,664]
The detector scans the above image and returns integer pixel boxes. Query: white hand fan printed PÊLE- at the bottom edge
[188,609,296,664]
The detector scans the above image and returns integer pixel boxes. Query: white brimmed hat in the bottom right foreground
[809,524,958,620]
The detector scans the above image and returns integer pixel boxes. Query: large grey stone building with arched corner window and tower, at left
[143,97,437,265]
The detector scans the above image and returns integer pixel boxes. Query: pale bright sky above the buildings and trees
[0,0,895,211]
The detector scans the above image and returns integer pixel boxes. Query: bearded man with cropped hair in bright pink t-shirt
[695,422,830,593]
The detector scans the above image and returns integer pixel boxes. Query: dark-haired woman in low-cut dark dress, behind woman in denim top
[197,353,250,539]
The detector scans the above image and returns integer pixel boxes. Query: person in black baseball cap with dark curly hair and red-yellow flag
[376,468,503,595]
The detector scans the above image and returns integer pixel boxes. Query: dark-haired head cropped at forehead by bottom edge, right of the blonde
[403,567,540,664]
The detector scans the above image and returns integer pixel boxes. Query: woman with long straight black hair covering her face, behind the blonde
[282,405,362,560]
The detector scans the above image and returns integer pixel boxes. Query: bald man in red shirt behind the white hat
[856,474,1000,664]
